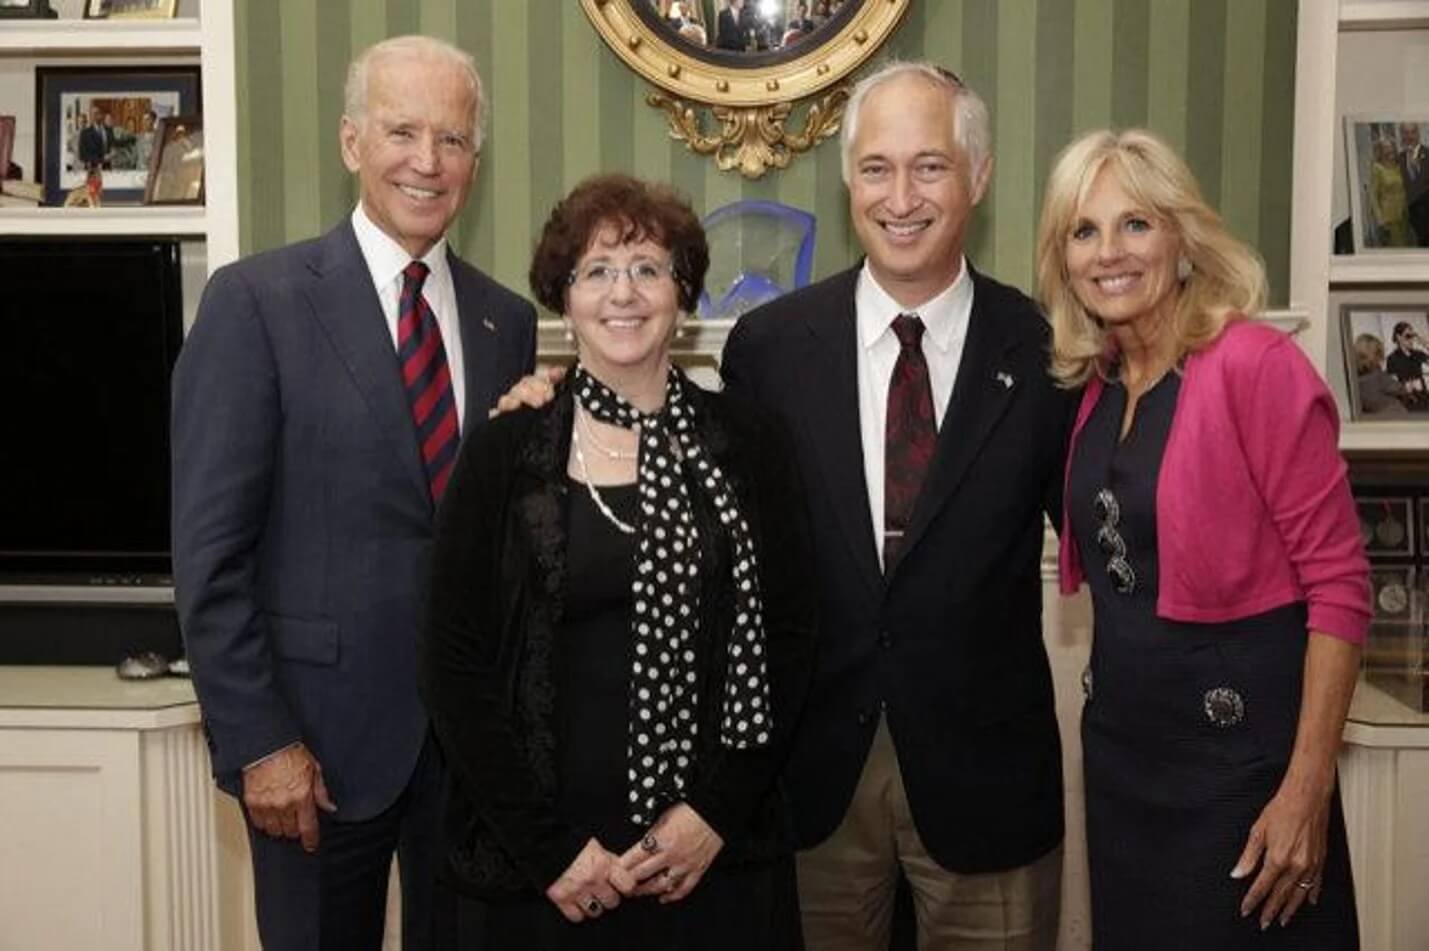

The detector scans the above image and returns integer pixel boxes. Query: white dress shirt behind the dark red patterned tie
[855,258,973,564]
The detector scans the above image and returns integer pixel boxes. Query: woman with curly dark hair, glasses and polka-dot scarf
[423,174,813,951]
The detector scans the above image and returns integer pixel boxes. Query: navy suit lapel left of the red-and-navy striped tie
[307,220,432,505]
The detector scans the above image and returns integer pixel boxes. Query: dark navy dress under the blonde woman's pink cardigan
[1066,373,1359,951]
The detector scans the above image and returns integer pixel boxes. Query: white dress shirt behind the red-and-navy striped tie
[353,201,466,433]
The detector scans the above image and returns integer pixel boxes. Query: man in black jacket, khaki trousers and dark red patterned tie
[722,63,1073,951]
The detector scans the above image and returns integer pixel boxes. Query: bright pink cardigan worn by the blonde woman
[1059,320,1370,643]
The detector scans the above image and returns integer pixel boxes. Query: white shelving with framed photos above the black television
[0,0,239,271]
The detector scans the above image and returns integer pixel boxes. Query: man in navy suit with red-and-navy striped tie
[173,37,536,951]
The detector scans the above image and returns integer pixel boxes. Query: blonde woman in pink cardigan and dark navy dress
[1037,130,1370,951]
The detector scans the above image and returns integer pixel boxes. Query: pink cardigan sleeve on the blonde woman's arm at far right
[1225,334,1370,644]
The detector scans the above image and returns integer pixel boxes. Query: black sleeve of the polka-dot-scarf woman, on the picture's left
[422,413,586,891]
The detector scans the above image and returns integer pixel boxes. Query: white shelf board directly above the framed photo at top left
[0,17,203,56]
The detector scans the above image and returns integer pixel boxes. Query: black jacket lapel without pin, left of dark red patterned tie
[795,267,883,594]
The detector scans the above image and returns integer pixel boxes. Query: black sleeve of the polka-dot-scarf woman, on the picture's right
[686,417,817,841]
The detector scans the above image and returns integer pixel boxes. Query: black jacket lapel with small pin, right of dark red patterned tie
[895,273,1026,562]
